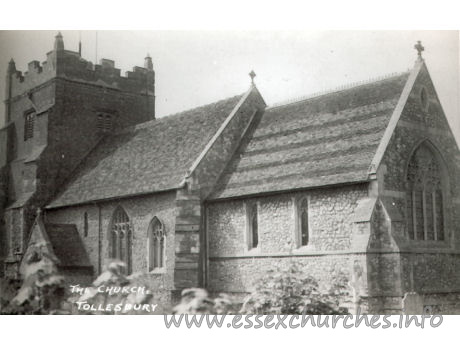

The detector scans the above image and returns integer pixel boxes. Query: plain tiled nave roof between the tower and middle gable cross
[48,95,242,208]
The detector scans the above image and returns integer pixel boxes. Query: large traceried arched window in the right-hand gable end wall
[407,143,445,241]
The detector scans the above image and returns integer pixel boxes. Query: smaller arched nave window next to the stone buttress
[148,217,166,271]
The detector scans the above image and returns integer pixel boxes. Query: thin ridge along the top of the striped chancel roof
[266,68,411,110]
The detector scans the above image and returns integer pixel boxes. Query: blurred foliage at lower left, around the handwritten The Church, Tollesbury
[1,243,153,315]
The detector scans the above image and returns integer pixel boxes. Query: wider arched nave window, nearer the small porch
[110,206,132,274]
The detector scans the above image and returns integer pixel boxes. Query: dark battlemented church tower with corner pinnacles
[0,33,155,275]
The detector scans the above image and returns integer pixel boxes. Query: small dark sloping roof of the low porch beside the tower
[45,223,92,267]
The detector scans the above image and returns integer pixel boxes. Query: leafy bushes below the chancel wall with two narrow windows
[173,264,350,315]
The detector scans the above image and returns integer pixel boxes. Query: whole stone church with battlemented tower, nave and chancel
[0,33,460,314]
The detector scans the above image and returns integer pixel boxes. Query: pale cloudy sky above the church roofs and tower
[0,30,460,142]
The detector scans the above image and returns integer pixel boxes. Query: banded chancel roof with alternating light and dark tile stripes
[211,72,409,199]
